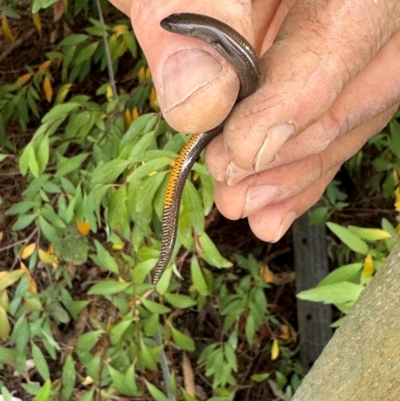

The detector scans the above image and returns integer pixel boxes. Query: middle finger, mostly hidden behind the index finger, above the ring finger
[211,31,400,185]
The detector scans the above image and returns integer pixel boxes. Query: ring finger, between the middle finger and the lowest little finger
[215,108,392,220]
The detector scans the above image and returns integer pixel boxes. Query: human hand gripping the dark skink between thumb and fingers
[109,0,400,241]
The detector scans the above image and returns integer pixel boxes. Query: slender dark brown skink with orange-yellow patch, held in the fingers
[153,13,261,285]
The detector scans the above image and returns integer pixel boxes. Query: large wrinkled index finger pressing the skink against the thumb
[224,0,399,171]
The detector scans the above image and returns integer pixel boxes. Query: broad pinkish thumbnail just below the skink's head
[162,49,222,112]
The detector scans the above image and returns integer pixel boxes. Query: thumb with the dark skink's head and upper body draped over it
[126,0,253,132]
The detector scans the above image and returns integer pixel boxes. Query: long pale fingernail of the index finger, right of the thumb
[253,123,294,171]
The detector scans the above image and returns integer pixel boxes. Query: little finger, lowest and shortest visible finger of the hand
[248,166,340,242]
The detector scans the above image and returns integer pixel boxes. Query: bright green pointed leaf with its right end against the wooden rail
[297,281,365,304]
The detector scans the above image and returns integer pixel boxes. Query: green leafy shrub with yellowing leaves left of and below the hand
[0,0,301,401]
